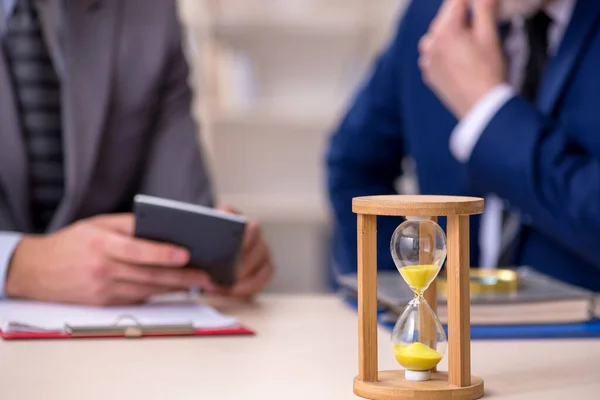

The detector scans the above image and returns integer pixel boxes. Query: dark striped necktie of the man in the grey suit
[4,0,64,232]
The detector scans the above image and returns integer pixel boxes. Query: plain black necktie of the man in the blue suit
[498,11,552,267]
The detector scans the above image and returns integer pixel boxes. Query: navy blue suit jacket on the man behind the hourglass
[327,0,600,291]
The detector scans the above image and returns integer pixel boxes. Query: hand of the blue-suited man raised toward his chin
[419,0,506,119]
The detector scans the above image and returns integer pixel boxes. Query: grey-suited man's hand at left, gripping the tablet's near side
[6,214,213,305]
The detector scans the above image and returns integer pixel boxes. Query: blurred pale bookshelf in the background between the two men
[179,0,406,292]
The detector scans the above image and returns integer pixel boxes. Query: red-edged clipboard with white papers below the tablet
[0,294,253,339]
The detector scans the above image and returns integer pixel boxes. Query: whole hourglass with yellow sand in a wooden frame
[352,196,484,400]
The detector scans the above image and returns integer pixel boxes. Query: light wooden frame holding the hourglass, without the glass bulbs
[352,195,484,400]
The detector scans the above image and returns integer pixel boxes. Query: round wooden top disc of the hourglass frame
[352,195,484,217]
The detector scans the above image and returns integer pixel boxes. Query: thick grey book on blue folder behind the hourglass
[338,267,599,325]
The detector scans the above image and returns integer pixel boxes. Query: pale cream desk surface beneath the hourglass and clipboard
[0,296,600,400]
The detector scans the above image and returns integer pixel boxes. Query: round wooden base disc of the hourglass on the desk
[354,371,483,400]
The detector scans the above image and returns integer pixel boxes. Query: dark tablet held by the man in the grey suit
[134,195,247,286]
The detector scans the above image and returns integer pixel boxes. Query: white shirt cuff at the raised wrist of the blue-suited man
[450,83,516,163]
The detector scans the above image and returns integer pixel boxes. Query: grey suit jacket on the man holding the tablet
[0,0,212,232]
